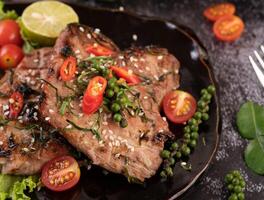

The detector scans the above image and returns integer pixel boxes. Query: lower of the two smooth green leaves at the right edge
[244,139,264,175]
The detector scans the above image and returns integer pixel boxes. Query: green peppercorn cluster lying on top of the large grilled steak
[104,77,131,128]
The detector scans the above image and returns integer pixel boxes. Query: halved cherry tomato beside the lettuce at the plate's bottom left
[41,156,81,192]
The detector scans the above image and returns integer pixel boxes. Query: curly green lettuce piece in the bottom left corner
[0,174,40,200]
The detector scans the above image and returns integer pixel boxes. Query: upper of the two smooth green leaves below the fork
[237,102,264,139]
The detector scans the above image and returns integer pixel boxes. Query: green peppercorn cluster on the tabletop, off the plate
[225,170,246,200]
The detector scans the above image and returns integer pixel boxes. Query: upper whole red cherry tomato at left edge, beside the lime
[0,19,23,46]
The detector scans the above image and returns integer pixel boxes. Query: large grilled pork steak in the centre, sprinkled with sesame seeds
[41,24,179,181]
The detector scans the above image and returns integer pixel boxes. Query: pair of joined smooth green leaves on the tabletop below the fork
[237,102,264,175]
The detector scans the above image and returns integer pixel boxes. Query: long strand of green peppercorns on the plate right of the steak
[160,85,215,179]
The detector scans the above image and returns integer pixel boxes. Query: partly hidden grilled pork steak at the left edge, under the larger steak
[0,48,67,175]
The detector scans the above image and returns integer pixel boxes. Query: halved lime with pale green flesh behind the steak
[21,1,79,46]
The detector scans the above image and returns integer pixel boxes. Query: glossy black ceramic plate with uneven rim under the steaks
[7,1,219,200]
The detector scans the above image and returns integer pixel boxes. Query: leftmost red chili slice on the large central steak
[60,56,77,81]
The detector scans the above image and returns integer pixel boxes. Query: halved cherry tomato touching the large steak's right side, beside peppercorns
[162,90,197,124]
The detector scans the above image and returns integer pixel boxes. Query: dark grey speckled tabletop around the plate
[9,0,264,200]
